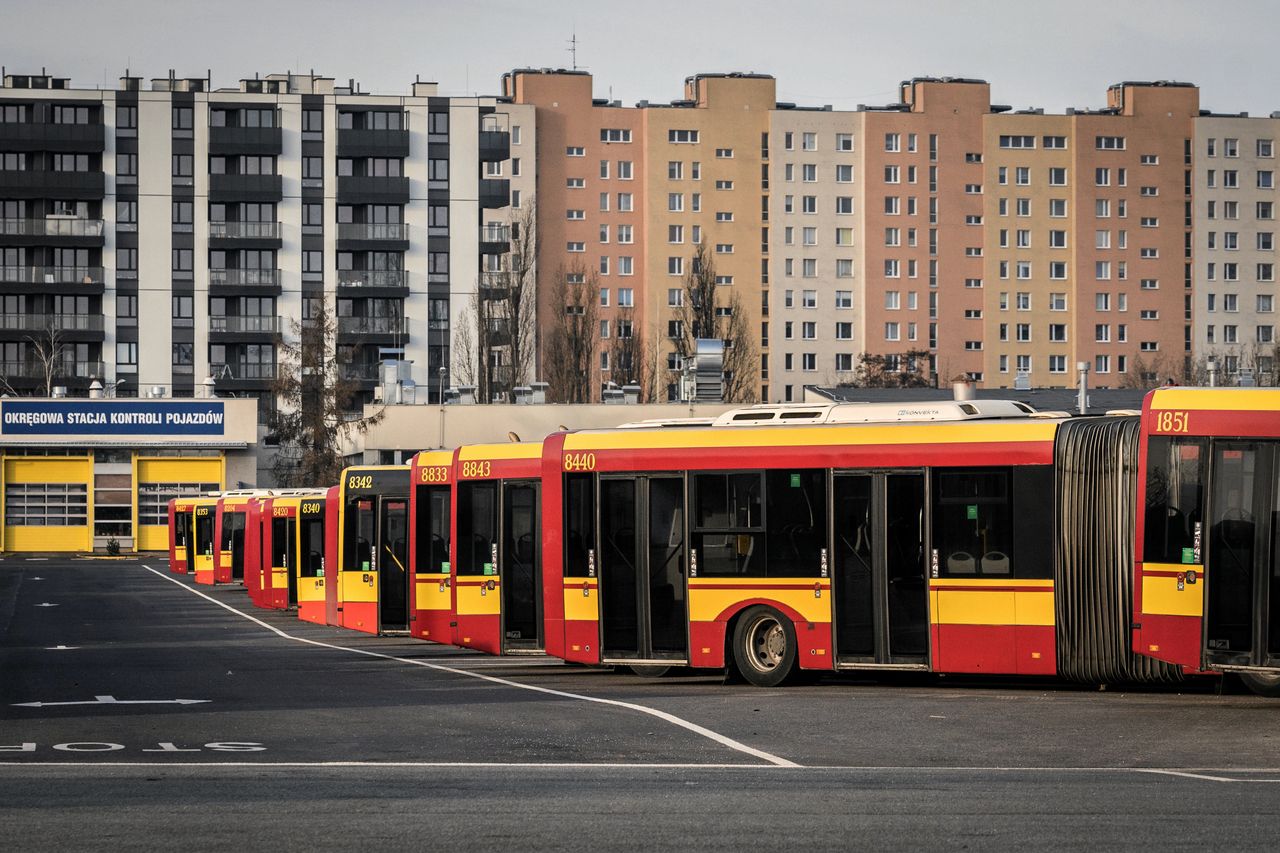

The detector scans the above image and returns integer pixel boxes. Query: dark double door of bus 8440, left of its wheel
[598,476,689,663]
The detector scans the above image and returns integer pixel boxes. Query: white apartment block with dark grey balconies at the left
[0,73,536,414]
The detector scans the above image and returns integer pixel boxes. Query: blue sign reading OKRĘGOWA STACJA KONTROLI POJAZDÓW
[0,400,227,435]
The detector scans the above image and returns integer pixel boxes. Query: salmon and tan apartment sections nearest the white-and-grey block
[503,69,774,398]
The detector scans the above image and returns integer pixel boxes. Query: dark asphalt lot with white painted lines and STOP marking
[0,557,1280,850]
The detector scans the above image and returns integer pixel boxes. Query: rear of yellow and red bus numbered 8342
[325,465,412,634]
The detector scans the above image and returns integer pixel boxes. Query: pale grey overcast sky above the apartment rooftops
[0,0,1280,115]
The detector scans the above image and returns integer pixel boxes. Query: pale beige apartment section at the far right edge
[1192,115,1280,384]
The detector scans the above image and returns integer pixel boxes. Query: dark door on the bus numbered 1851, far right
[1203,439,1280,667]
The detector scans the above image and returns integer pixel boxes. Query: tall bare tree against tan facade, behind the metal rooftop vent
[675,243,759,402]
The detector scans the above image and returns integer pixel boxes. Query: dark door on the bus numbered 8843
[499,480,543,651]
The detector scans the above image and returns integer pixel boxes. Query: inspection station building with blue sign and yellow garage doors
[0,397,259,552]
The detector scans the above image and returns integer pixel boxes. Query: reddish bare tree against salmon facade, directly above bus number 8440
[544,265,600,402]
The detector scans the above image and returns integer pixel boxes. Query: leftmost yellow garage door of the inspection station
[4,456,93,552]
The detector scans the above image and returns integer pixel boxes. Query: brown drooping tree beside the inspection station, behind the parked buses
[270,301,385,487]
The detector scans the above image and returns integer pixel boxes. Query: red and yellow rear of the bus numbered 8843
[452,442,543,654]
